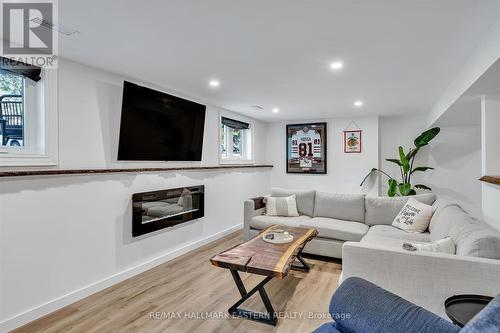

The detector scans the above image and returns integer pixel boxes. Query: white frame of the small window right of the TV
[217,112,254,164]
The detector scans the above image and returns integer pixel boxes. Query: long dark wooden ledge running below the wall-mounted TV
[0,164,273,178]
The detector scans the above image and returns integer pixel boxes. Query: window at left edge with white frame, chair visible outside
[0,63,58,166]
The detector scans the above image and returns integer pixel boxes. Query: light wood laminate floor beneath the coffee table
[13,231,342,333]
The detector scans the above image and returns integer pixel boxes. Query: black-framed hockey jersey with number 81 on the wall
[286,123,326,174]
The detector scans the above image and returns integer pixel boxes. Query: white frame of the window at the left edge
[0,69,59,167]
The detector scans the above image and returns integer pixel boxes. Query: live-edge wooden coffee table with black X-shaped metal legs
[210,225,318,326]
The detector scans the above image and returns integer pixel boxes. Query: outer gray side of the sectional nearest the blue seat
[342,242,500,318]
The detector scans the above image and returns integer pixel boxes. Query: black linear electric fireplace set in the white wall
[132,185,205,237]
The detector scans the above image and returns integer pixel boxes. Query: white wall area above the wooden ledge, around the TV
[59,61,266,168]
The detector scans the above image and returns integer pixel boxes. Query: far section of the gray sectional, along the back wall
[244,188,436,258]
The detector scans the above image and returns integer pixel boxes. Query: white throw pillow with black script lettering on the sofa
[392,198,432,232]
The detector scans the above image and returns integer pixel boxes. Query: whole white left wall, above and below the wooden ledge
[0,61,270,332]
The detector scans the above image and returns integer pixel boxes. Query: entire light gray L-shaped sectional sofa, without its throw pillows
[244,189,500,317]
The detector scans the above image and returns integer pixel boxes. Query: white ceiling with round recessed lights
[59,0,500,121]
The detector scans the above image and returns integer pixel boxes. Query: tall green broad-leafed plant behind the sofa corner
[360,127,440,197]
